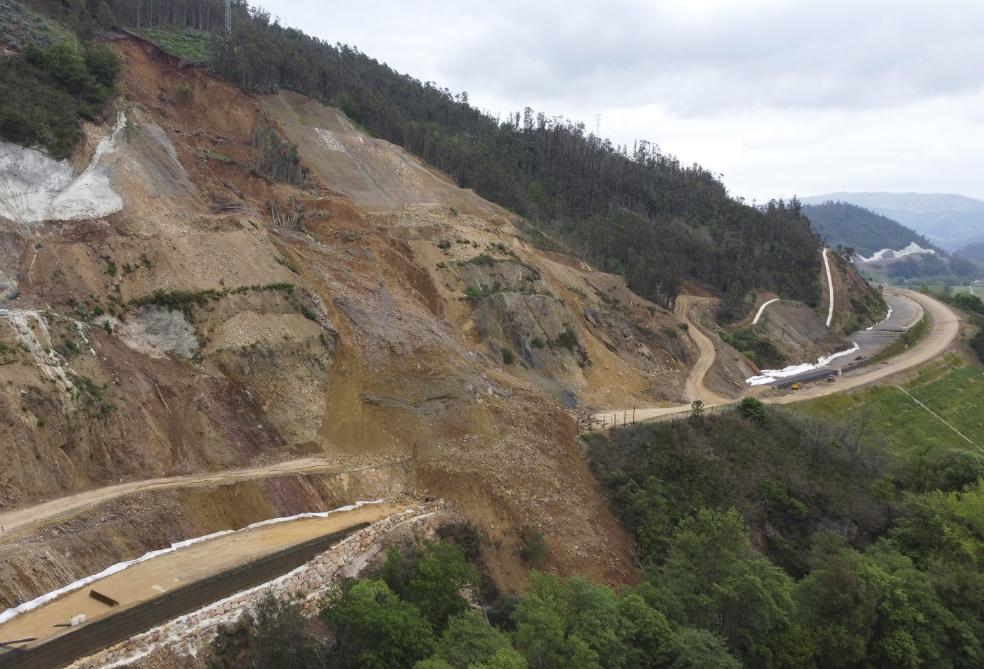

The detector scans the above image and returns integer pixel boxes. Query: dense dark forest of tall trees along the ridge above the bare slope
[19,0,820,318]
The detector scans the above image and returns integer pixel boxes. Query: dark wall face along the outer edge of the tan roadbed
[0,523,369,669]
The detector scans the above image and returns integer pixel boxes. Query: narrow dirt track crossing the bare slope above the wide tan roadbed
[0,458,402,540]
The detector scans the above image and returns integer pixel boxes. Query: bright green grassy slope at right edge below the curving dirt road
[798,355,984,456]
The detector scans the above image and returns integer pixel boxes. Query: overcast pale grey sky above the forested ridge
[260,0,984,201]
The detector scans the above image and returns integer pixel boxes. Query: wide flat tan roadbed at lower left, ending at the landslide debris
[0,503,401,649]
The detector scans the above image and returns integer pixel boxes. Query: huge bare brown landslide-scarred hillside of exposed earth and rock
[0,32,720,596]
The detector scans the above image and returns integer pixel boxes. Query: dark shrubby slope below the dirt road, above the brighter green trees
[588,402,888,575]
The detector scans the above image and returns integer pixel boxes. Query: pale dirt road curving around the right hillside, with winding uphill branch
[595,288,960,424]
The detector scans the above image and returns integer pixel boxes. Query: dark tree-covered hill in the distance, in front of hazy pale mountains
[803,201,933,257]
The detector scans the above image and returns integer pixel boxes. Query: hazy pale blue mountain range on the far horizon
[800,192,984,251]
